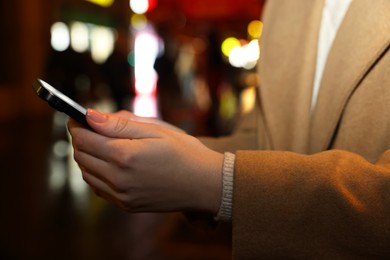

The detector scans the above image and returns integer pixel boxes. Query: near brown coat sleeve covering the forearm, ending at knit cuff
[233,150,390,259]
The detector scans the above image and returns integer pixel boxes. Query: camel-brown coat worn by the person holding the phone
[202,0,390,259]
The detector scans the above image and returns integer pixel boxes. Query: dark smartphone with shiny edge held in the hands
[33,79,89,127]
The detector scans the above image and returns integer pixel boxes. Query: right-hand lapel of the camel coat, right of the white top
[310,0,390,153]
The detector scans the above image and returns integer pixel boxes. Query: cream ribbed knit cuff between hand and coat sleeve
[215,153,236,221]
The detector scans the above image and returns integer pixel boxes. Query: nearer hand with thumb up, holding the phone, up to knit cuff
[68,110,223,214]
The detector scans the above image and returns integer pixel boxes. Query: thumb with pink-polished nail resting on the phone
[86,109,161,139]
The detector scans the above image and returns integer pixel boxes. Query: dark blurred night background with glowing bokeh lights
[0,0,263,259]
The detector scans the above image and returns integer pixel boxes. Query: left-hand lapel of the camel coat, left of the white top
[259,0,324,153]
